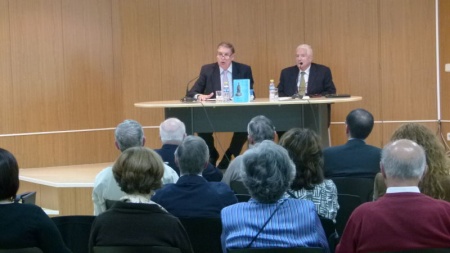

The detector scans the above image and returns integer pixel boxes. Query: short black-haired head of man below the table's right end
[345,108,374,139]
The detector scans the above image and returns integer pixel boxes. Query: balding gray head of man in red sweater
[381,139,426,181]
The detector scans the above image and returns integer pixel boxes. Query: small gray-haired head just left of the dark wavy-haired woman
[247,115,275,143]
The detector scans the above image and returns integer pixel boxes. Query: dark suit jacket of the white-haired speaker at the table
[278,63,336,97]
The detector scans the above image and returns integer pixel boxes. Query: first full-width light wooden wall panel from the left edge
[9,0,68,133]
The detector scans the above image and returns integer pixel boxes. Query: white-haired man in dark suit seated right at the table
[278,44,336,97]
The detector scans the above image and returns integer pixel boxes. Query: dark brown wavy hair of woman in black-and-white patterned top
[279,128,324,191]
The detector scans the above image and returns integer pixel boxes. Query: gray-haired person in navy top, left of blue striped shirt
[152,136,237,218]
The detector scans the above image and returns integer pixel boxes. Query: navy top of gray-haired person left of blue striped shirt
[152,175,237,218]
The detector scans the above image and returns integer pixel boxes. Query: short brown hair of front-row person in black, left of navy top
[112,147,164,194]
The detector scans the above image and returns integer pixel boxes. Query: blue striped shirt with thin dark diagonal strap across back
[222,198,328,252]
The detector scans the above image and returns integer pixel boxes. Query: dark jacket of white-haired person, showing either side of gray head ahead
[155,144,223,182]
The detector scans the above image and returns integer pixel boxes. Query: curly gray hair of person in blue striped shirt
[242,140,295,203]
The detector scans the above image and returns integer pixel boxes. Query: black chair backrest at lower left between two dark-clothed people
[51,215,95,253]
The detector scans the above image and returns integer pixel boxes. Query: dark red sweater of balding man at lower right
[336,193,450,253]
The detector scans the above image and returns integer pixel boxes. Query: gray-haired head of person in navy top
[175,135,209,175]
